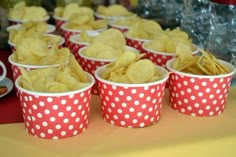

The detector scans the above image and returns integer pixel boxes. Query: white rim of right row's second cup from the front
[142,41,199,57]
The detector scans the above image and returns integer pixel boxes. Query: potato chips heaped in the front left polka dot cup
[20,56,90,93]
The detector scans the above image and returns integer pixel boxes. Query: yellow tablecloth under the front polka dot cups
[0,87,236,157]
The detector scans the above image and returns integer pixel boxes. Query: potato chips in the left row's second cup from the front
[12,38,71,65]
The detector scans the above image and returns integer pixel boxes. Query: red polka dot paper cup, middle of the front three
[95,65,168,128]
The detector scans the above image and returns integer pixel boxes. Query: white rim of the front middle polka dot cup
[94,64,169,87]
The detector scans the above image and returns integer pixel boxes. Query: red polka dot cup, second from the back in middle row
[61,24,107,47]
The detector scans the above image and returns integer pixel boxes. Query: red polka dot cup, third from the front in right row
[124,33,151,53]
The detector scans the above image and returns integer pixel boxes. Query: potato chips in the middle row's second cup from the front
[83,28,126,59]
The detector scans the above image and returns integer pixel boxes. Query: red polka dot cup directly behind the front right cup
[142,42,199,68]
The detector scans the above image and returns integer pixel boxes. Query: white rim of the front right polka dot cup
[166,58,236,78]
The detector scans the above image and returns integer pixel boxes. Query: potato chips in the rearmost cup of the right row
[97,4,133,16]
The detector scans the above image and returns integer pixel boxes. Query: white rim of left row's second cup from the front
[8,54,68,69]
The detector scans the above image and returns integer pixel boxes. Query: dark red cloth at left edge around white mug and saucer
[0,49,23,124]
